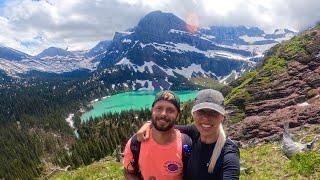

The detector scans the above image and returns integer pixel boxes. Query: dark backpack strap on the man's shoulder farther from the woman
[130,134,142,179]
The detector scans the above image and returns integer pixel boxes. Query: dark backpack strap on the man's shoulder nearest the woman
[181,133,192,179]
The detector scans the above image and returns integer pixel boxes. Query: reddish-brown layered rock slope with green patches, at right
[226,26,320,142]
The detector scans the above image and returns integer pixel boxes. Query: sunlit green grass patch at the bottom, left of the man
[50,157,124,180]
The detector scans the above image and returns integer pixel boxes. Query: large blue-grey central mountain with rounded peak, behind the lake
[94,11,294,89]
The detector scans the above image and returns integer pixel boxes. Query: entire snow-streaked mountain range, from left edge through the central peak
[0,11,295,89]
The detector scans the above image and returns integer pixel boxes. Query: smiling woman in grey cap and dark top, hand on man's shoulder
[137,89,240,180]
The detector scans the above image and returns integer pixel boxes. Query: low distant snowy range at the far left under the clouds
[0,43,110,77]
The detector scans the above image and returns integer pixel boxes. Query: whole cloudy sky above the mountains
[0,0,320,55]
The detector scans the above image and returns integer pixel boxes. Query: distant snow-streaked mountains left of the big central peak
[0,40,111,78]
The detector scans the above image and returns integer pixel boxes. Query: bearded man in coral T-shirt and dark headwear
[123,91,188,180]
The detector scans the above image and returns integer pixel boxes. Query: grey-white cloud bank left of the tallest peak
[0,0,147,54]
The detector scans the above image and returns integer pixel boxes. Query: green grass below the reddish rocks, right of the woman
[240,143,320,179]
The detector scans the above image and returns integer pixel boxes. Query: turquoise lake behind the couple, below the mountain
[81,91,197,121]
